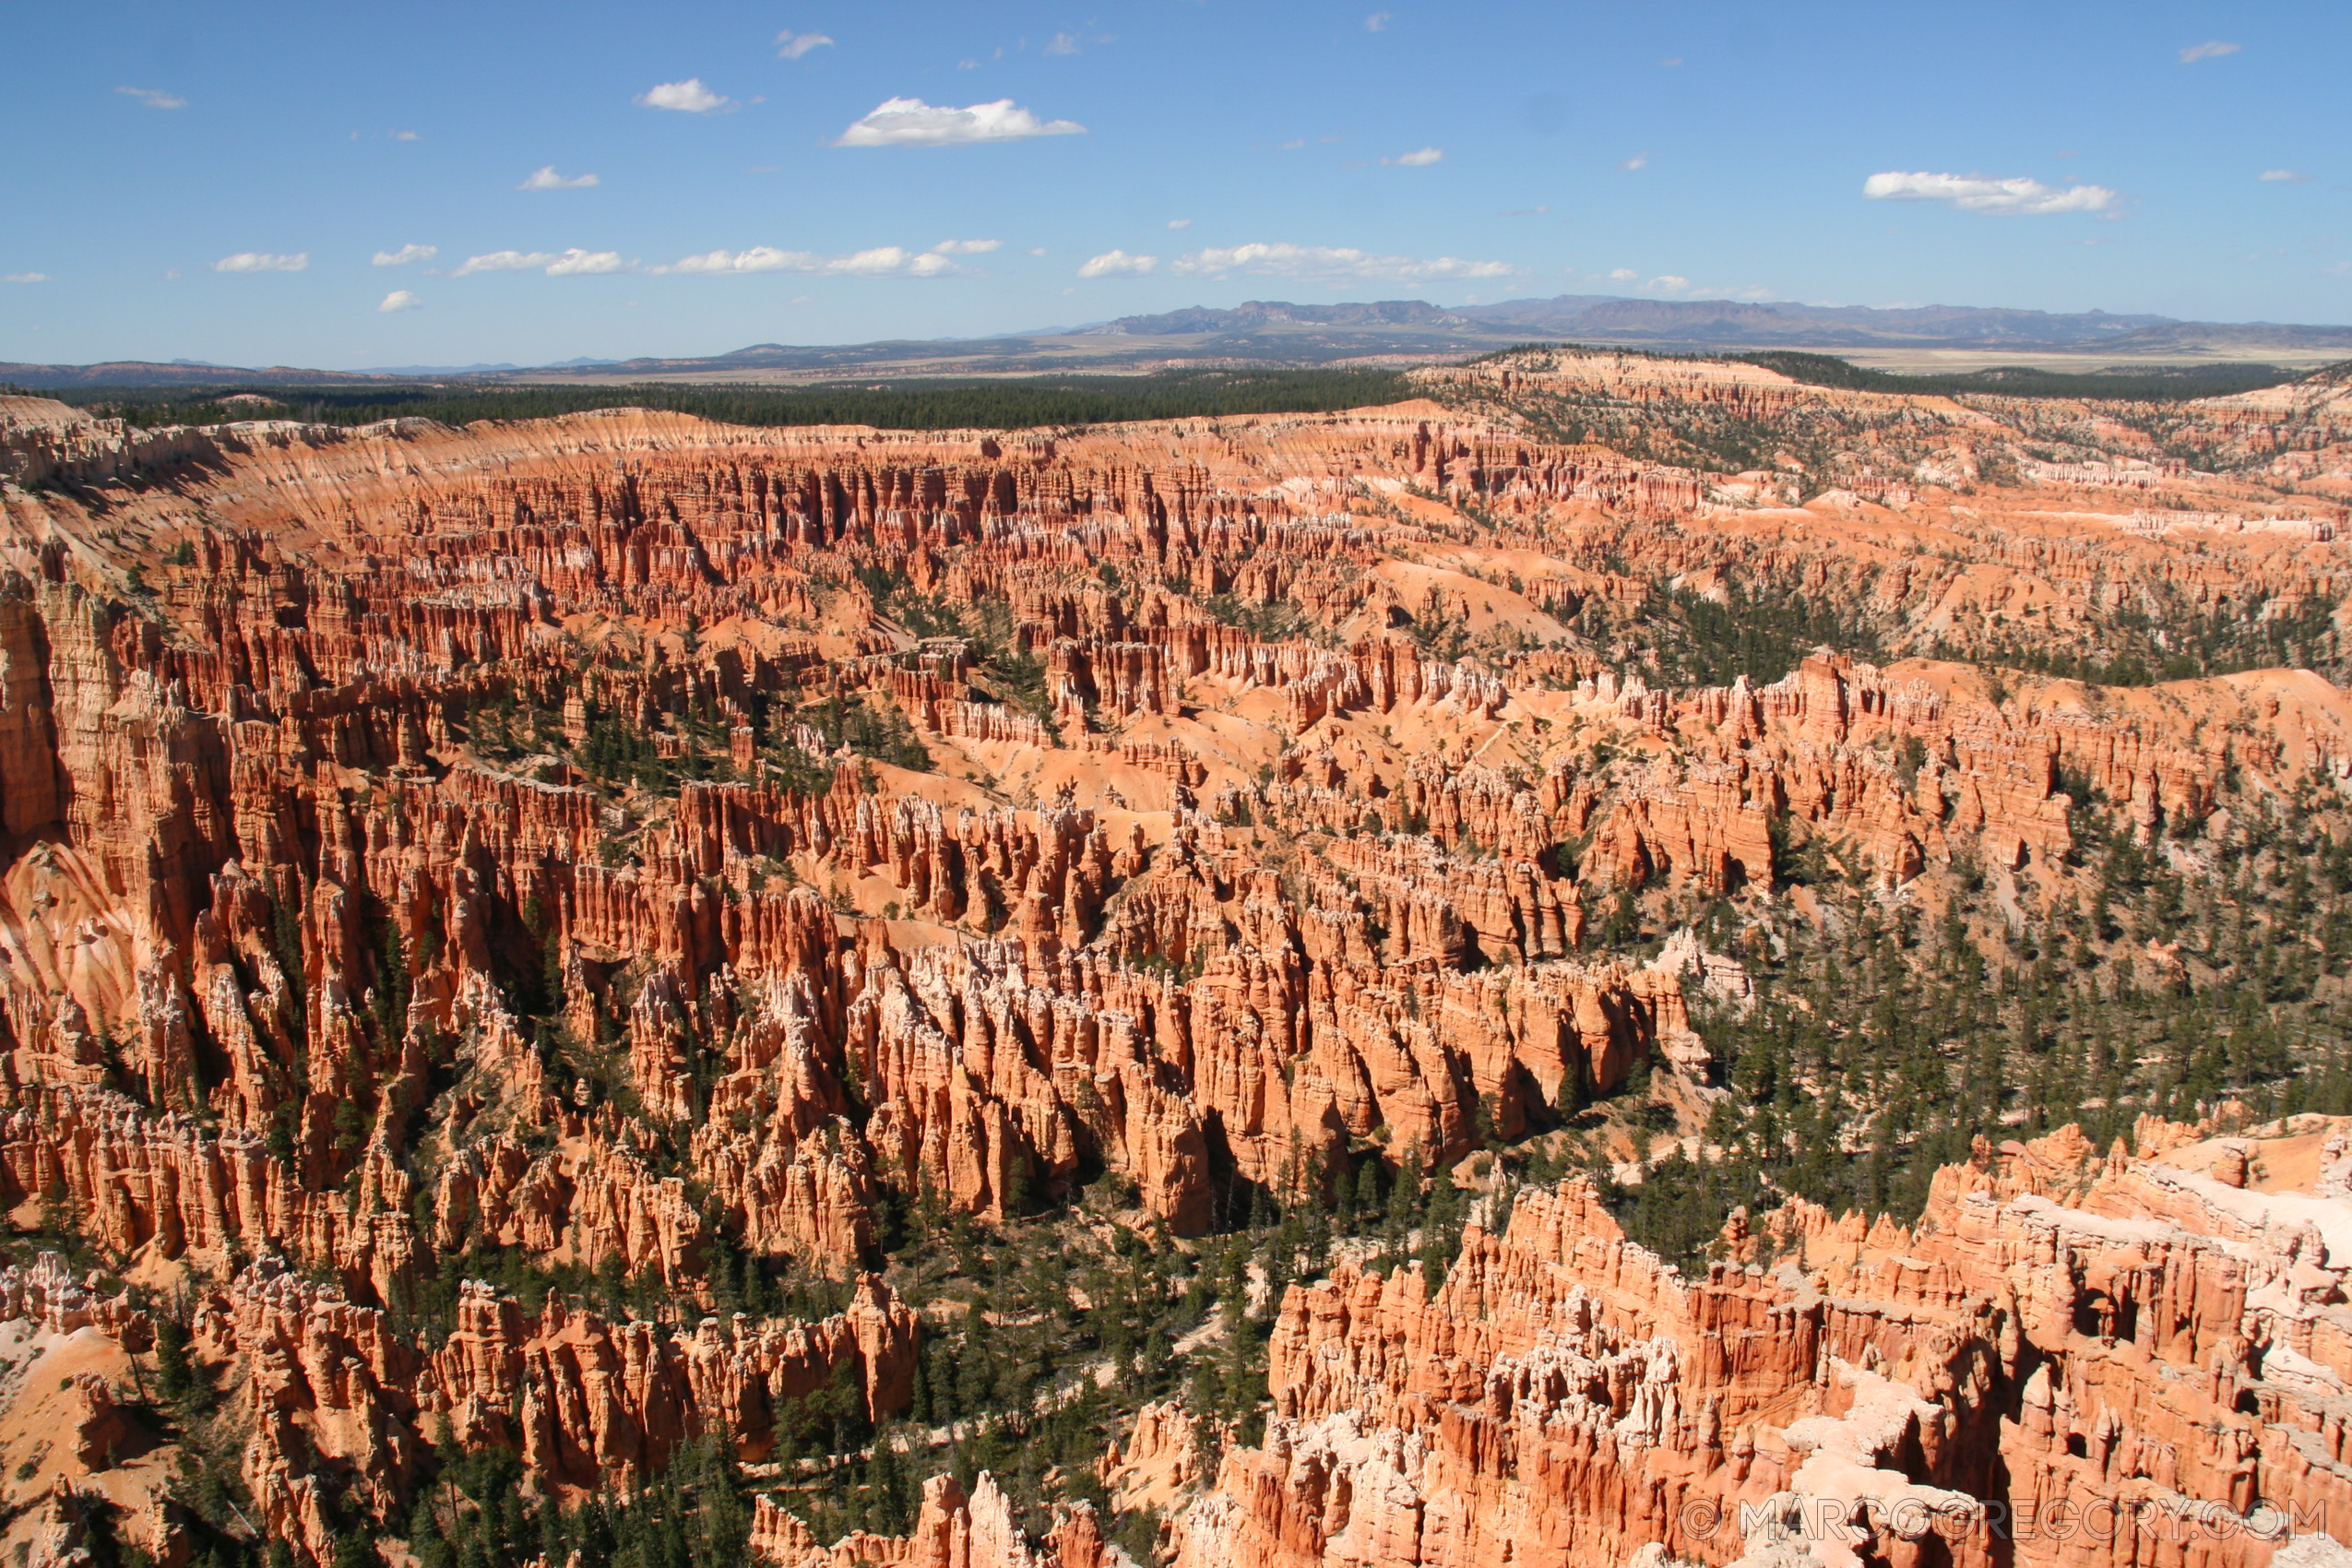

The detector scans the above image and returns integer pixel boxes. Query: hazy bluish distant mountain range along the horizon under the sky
[0,294,2352,390]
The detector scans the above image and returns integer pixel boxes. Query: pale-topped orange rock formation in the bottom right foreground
[1176,1119,2352,1568]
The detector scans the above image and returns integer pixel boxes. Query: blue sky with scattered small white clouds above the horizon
[0,0,2352,367]
